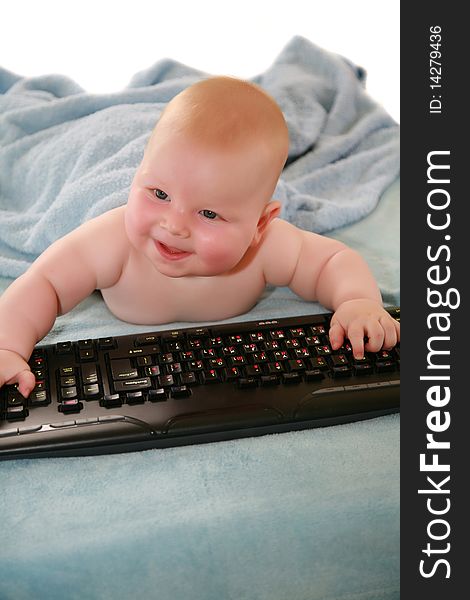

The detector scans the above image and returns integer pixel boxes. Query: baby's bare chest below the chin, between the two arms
[101,255,265,324]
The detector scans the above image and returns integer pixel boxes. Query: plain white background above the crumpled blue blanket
[0,0,400,121]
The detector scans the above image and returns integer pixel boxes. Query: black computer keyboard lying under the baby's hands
[0,307,400,459]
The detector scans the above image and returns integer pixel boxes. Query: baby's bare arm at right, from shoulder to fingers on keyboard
[265,221,400,358]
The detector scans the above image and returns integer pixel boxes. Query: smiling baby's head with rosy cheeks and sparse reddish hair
[126,77,289,276]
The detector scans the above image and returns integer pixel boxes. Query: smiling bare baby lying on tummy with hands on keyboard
[0,77,399,396]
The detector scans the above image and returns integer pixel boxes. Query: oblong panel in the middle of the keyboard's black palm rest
[163,405,282,435]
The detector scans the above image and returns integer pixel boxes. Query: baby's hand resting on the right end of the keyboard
[330,299,400,358]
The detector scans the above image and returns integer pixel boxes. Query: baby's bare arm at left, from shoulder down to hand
[0,211,125,397]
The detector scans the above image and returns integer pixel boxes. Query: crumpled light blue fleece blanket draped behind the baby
[0,37,399,277]
